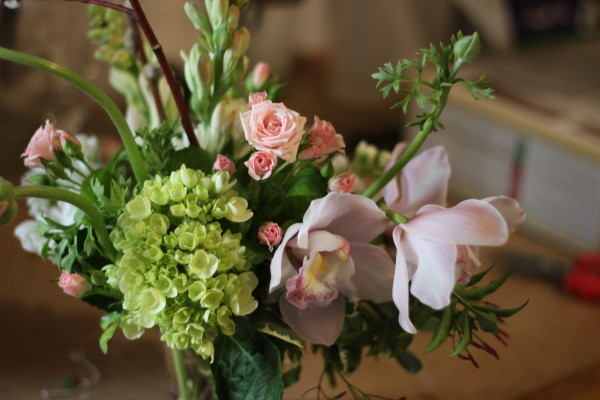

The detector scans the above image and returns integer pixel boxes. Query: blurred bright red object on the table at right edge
[563,253,600,301]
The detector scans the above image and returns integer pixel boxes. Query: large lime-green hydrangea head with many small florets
[104,165,258,358]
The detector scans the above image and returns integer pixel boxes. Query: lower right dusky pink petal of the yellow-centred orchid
[338,243,394,303]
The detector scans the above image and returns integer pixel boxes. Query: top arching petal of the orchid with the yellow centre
[298,192,388,248]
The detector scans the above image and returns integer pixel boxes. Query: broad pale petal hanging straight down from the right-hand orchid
[403,235,457,310]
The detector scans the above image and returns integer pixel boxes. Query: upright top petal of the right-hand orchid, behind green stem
[390,146,450,218]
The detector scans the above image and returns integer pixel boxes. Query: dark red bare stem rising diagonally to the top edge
[129,0,200,146]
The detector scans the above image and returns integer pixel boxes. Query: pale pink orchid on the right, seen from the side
[382,146,525,333]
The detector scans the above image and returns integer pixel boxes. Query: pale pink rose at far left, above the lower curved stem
[21,120,79,167]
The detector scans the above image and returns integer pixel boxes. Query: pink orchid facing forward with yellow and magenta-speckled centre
[270,192,394,345]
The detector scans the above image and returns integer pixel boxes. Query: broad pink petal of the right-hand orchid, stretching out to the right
[400,200,508,246]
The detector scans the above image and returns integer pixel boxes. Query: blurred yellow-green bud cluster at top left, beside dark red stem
[88,5,135,69]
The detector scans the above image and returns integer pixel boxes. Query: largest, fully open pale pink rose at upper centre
[240,100,306,162]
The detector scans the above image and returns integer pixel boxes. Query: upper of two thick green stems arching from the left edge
[0,47,148,182]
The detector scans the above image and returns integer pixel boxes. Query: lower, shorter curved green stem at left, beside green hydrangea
[13,186,117,261]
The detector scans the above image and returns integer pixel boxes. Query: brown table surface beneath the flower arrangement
[0,216,600,400]
